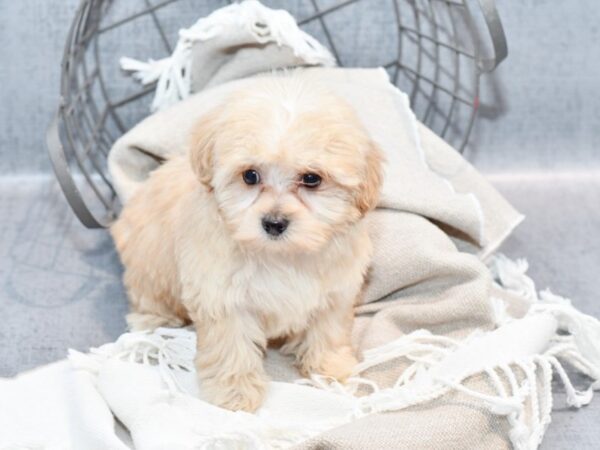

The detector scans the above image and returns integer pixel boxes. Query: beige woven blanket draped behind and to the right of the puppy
[109,1,600,449]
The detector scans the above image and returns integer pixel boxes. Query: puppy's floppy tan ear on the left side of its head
[190,111,218,190]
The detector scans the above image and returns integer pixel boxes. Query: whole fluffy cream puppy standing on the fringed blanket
[111,75,382,411]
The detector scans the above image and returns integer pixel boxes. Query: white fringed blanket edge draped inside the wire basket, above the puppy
[120,0,335,111]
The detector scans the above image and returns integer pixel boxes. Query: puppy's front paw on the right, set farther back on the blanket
[299,346,358,381]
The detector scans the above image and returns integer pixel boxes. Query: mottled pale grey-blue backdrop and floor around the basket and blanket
[0,0,600,448]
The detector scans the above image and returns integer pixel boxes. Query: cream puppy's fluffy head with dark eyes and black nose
[191,79,381,253]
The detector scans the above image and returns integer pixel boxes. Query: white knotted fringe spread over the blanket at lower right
[303,255,600,450]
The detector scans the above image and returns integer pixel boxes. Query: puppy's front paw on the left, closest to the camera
[201,373,268,412]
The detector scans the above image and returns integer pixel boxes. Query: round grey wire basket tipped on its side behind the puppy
[47,0,507,228]
